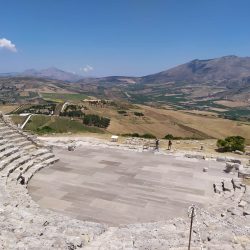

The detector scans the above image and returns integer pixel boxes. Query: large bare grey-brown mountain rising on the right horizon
[141,56,250,85]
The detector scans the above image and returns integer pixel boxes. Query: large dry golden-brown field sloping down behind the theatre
[61,101,250,143]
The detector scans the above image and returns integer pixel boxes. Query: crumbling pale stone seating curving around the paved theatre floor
[0,115,250,250]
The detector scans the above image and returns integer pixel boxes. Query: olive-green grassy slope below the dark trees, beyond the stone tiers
[20,115,104,134]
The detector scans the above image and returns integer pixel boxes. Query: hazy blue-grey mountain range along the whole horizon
[0,56,250,84]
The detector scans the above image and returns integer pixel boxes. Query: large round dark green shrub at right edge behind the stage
[217,136,245,152]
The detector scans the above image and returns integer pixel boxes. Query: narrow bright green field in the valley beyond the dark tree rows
[41,93,87,102]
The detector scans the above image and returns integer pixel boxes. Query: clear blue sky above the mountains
[0,0,250,76]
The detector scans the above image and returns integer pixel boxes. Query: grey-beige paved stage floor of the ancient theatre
[28,147,228,225]
